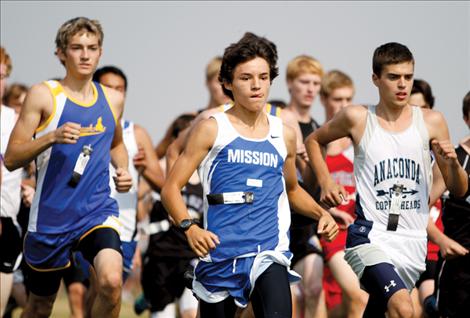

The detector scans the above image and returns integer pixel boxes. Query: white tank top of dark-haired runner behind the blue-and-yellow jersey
[109,120,139,242]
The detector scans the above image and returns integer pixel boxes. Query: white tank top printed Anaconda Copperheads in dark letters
[354,106,432,236]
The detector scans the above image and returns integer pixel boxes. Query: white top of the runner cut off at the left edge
[0,105,23,223]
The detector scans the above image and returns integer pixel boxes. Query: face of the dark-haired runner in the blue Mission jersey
[225,57,271,111]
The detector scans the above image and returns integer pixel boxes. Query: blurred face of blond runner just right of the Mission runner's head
[287,73,321,107]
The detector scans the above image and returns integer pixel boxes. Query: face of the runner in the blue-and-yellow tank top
[59,31,102,76]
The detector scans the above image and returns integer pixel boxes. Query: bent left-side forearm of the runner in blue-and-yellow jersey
[4,132,56,171]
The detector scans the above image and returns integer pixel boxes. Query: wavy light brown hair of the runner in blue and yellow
[55,17,104,52]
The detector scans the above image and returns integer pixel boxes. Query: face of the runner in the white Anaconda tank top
[372,62,414,107]
